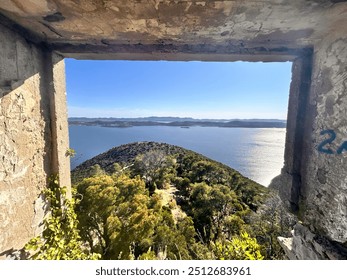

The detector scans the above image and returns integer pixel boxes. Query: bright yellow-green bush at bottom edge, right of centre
[212,232,264,260]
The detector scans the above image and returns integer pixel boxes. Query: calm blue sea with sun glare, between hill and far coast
[69,125,286,186]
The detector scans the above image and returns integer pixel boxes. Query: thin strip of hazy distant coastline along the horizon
[69,117,287,128]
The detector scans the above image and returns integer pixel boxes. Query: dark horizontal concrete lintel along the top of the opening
[50,43,312,62]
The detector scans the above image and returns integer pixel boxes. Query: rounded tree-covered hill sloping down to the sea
[67,142,293,259]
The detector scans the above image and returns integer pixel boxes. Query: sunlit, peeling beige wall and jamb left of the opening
[0,24,69,258]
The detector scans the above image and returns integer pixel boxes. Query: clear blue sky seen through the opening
[65,59,291,119]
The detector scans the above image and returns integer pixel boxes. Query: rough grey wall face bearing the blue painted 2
[299,34,347,243]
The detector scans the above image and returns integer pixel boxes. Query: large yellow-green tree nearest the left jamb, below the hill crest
[76,175,159,259]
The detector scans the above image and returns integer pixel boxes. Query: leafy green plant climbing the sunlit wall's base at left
[25,178,100,260]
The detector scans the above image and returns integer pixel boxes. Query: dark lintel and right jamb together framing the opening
[62,48,313,213]
